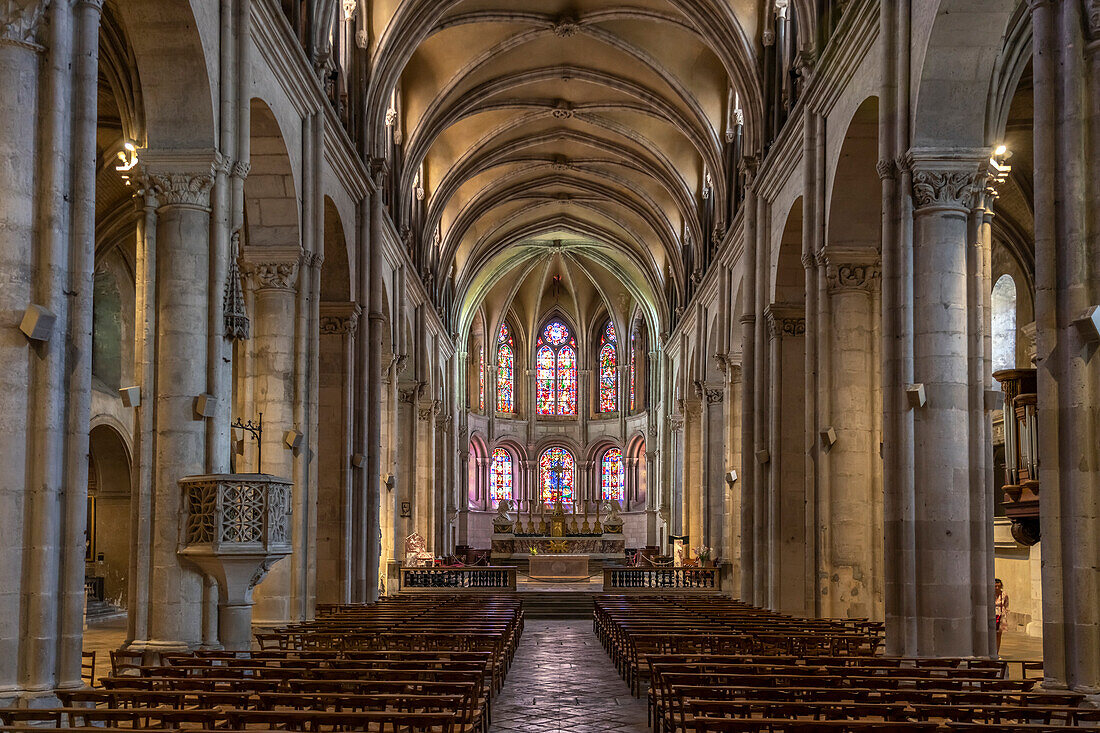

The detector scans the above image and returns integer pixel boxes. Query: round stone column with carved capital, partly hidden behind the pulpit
[245,247,309,624]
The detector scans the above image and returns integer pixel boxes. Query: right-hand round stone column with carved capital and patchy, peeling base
[815,247,883,619]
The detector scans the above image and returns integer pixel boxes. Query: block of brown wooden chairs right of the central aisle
[593,595,1100,733]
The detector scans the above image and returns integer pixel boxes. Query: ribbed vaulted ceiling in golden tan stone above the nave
[367,0,759,338]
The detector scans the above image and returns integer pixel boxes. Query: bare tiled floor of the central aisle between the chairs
[490,621,649,733]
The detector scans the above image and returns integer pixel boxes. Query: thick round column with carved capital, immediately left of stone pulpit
[137,151,213,652]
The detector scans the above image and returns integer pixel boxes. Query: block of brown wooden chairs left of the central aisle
[0,595,523,733]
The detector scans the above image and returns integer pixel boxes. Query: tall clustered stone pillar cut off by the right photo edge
[1030,0,1100,696]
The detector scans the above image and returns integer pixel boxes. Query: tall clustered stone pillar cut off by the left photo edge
[0,1,68,704]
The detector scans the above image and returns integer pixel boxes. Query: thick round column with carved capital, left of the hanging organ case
[908,151,992,656]
